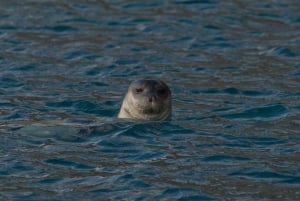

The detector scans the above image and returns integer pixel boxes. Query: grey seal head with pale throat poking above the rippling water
[118,78,172,121]
